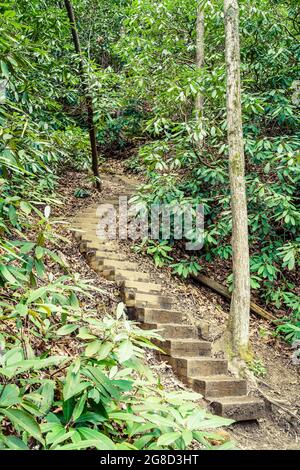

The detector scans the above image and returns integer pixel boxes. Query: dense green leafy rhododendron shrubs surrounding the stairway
[0,0,300,450]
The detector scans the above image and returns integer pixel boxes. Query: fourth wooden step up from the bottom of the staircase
[153,339,211,356]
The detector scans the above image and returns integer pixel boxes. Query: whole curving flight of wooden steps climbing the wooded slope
[73,177,264,421]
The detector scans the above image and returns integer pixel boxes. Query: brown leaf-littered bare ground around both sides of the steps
[53,160,300,450]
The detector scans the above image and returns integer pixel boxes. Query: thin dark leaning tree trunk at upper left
[64,0,101,191]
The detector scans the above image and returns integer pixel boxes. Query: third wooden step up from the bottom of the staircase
[171,357,228,377]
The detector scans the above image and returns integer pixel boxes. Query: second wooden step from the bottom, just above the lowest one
[191,375,247,397]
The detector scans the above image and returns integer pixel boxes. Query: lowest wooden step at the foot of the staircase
[207,395,265,421]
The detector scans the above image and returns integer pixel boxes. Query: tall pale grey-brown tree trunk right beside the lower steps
[224,0,250,358]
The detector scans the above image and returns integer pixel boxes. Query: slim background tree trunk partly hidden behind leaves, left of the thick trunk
[195,0,205,146]
